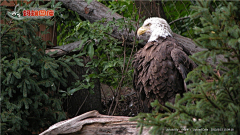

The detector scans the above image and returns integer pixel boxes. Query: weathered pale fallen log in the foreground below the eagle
[40,110,150,135]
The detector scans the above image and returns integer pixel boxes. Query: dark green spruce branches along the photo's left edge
[0,1,79,135]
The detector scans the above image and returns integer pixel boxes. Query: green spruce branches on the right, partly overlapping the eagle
[132,1,240,134]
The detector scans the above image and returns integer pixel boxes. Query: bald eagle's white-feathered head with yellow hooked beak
[137,17,173,42]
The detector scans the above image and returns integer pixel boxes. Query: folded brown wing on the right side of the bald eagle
[171,47,197,79]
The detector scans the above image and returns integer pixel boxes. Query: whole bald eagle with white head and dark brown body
[132,17,196,112]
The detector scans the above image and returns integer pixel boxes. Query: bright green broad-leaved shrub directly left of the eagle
[57,1,141,105]
